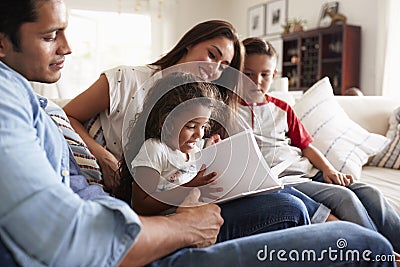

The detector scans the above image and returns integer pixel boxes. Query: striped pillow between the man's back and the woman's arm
[46,101,102,183]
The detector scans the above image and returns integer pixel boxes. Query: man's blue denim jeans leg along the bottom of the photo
[149,222,395,267]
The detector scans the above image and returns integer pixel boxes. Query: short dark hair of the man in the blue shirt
[0,0,42,52]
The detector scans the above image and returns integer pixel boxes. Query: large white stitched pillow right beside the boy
[293,77,389,179]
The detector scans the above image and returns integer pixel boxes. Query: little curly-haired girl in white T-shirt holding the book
[127,73,220,215]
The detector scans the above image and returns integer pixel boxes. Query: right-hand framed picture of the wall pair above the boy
[265,0,287,35]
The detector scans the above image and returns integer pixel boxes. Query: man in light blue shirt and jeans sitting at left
[0,0,394,266]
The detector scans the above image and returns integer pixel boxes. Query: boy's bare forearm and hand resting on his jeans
[302,144,353,186]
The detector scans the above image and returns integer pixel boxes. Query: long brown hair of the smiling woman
[151,20,243,73]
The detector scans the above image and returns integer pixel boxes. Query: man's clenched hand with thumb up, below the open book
[173,188,224,248]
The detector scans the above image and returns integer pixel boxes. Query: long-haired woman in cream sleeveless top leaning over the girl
[64,20,243,192]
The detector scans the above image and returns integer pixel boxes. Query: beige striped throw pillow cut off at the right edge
[369,107,400,169]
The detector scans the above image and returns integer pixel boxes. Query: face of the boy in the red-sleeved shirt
[243,54,277,103]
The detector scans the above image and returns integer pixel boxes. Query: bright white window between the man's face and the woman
[53,9,152,98]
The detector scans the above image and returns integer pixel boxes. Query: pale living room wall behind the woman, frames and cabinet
[171,0,386,95]
